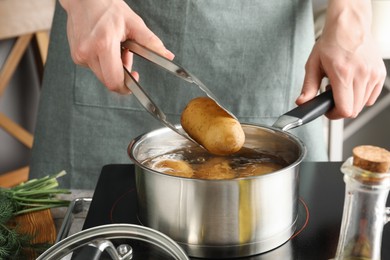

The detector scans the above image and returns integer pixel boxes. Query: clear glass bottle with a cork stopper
[334,146,390,260]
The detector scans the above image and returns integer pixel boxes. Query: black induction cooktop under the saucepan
[83,162,390,260]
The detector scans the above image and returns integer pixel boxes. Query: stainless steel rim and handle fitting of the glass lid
[37,224,188,260]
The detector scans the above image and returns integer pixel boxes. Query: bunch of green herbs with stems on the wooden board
[0,171,70,259]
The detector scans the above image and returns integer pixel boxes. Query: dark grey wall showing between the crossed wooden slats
[0,40,40,173]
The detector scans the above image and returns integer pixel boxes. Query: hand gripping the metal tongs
[60,0,174,94]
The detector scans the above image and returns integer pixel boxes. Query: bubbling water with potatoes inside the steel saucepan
[143,147,288,179]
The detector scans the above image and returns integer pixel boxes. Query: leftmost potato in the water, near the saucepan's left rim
[152,159,193,178]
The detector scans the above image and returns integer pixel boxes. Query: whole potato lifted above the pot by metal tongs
[181,97,245,155]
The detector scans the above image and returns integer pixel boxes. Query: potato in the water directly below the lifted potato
[194,157,236,180]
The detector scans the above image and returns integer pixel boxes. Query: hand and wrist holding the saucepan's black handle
[296,0,386,119]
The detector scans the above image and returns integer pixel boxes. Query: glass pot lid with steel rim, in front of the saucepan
[37,224,189,260]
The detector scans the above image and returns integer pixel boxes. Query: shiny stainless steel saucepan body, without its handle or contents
[128,124,306,258]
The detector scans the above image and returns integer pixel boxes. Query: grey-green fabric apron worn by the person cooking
[30,0,327,188]
